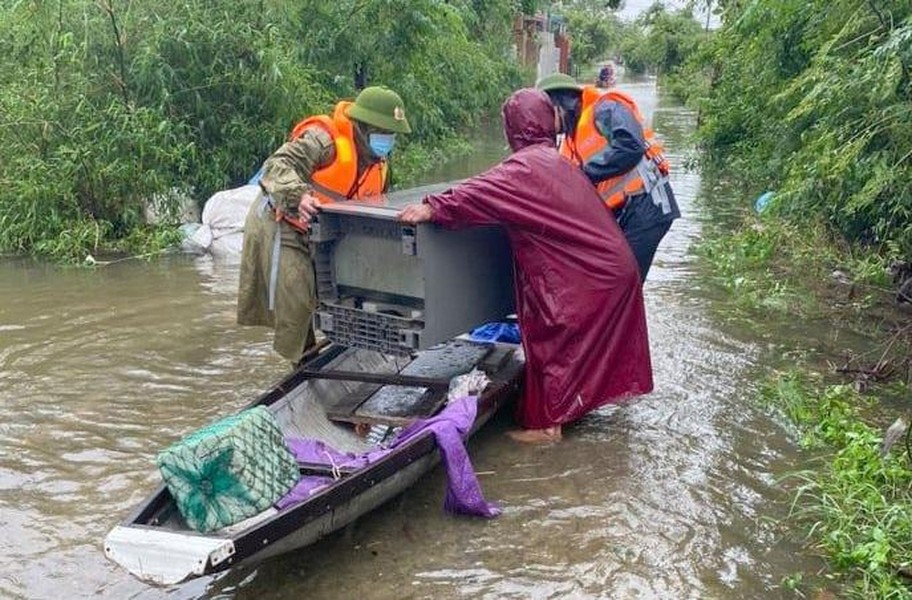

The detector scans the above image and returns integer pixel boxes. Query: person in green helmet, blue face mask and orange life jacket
[237,86,411,364]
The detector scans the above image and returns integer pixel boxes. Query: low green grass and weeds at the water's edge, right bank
[698,191,912,599]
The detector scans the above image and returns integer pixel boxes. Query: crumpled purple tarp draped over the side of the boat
[275,396,500,518]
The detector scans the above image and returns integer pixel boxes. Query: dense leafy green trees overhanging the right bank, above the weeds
[701,0,912,258]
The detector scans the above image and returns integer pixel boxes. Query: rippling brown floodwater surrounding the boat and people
[0,81,821,600]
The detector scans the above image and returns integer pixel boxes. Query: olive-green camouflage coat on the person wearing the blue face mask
[238,128,335,362]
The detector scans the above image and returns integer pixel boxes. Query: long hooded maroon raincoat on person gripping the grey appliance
[424,89,652,429]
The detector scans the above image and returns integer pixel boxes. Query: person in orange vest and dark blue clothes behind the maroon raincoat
[536,73,681,281]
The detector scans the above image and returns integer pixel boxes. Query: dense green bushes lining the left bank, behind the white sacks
[0,0,522,259]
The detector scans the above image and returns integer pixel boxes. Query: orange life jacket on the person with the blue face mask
[289,101,389,203]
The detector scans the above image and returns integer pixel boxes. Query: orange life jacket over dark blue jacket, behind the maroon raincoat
[560,85,669,209]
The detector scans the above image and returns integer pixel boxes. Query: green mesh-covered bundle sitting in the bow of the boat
[156,406,299,533]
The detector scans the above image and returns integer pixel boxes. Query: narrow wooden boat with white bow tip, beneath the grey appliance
[104,339,522,585]
